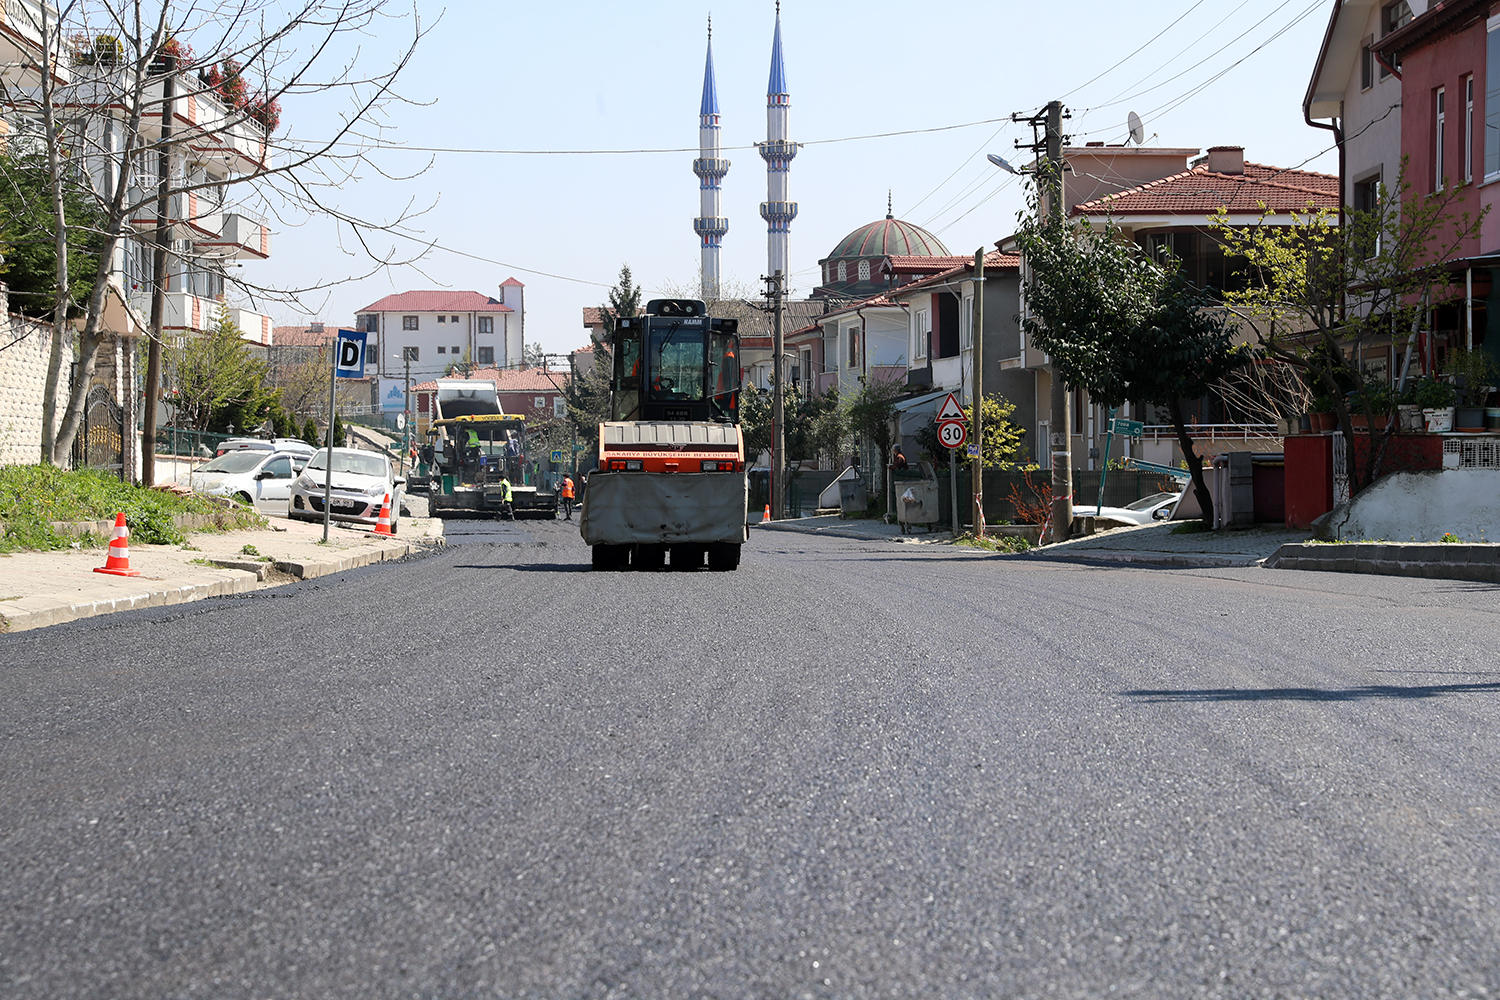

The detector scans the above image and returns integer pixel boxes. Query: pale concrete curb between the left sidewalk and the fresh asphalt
[0,538,446,633]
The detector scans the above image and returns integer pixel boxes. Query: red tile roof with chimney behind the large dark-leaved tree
[1073,163,1338,217]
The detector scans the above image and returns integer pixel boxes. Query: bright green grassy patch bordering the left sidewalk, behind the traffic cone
[0,465,263,552]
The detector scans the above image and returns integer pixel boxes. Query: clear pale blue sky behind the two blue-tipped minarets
[245,0,1338,367]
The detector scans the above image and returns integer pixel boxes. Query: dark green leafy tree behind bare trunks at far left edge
[0,153,104,319]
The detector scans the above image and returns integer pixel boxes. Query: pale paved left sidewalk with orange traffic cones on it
[0,517,443,631]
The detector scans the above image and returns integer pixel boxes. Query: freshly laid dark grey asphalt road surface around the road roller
[0,523,1500,1000]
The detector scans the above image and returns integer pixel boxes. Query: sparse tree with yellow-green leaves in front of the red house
[1214,160,1488,496]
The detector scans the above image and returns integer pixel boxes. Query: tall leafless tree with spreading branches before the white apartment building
[0,0,425,463]
